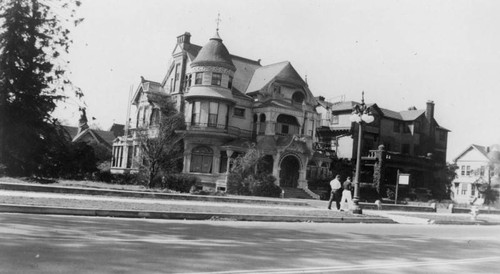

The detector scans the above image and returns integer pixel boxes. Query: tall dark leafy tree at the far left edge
[0,0,83,175]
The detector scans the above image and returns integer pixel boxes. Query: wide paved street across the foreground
[0,214,500,273]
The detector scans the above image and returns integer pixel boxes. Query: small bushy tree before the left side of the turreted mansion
[136,94,185,188]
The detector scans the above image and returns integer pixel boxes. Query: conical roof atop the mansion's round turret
[191,32,236,71]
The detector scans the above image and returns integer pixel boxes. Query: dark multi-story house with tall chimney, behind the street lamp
[318,97,449,191]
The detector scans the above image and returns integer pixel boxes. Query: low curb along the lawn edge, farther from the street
[0,182,309,206]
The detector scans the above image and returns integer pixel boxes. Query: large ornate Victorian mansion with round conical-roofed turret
[112,32,331,193]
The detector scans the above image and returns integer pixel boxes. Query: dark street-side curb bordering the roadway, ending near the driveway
[0,204,396,224]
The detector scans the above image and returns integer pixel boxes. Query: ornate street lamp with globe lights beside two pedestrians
[349,91,375,214]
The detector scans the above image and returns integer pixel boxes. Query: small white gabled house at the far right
[452,145,496,204]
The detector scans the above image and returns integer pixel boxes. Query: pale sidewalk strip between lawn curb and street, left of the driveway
[0,185,393,223]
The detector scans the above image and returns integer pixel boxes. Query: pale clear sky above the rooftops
[51,0,500,161]
